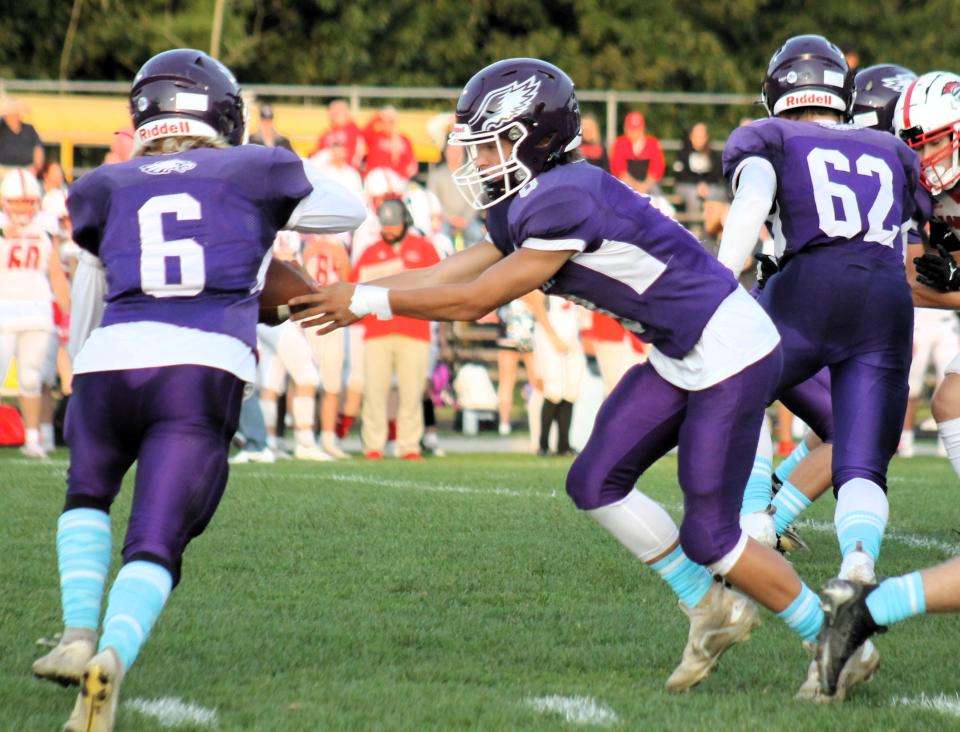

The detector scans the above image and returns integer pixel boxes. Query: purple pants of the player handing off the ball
[567,348,781,564]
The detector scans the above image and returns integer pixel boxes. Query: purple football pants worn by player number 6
[64,365,244,584]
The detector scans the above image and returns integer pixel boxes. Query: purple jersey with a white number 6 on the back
[68,145,312,349]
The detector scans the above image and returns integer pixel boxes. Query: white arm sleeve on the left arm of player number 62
[717,158,777,276]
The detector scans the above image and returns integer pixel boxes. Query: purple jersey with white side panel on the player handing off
[487,162,737,358]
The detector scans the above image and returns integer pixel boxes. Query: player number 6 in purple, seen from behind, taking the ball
[33,49,365,732]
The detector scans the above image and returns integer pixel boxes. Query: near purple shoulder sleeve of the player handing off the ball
[511,186,597,247]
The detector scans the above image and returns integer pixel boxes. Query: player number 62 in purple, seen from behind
[718,35,922,698]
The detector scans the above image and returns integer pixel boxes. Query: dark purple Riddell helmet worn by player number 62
[760,35,853,117]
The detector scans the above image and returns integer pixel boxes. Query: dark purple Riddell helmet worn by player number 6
[130,48,247,154]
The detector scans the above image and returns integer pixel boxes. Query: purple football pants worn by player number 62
[760,244,913,491]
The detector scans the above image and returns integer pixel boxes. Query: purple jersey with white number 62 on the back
[723,118,925,264]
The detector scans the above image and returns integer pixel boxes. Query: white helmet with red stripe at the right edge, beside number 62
[893,71,960,196]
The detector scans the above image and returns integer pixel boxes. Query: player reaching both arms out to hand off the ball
[291,59,840,691]
